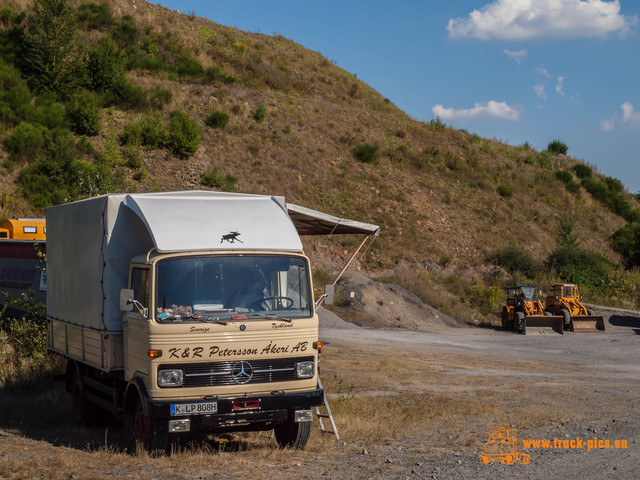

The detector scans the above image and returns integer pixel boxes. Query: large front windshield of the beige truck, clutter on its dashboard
[156,255,311,322]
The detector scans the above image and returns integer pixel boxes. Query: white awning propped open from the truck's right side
[287,203,380,235]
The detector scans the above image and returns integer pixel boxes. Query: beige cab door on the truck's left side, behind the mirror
[122,266,151,383]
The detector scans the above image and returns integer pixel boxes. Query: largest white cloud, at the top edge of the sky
[447,0,637,40]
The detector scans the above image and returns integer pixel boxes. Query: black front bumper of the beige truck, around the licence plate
[147,388,324,433]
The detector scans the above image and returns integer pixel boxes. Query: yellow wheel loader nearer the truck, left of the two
[502,284,564,335]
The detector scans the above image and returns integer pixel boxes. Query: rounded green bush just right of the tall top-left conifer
[85,38,124,90]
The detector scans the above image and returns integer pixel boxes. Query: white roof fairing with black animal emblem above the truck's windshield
[124,191,302,253]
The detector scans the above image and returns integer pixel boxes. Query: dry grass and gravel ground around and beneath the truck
[0,302,640,479]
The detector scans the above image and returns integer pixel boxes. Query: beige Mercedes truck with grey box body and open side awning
[46,191,378,453]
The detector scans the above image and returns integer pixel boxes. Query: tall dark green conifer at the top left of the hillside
[24,0,77,97]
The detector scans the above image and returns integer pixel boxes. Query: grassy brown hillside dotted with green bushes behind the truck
[0,0,640,321]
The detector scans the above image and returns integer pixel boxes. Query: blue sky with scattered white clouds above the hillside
[158,0,640,193]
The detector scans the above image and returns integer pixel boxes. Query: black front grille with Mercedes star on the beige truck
[158,357,313,387]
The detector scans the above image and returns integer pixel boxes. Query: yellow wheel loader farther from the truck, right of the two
[545,283,605,332]
